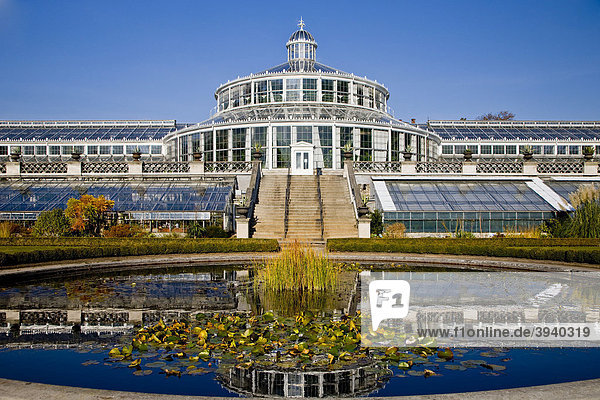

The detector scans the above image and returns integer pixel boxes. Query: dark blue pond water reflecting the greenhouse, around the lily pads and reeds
[0,266,600,397]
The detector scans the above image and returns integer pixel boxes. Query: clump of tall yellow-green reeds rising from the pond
[255,242,339,292]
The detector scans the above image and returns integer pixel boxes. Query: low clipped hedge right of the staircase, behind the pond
[327,238,600,264]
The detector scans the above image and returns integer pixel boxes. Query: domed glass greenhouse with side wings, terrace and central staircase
[0,21,600,241]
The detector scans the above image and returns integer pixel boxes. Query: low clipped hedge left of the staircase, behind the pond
[0,238,279,266]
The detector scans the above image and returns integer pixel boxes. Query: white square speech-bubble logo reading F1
[369,280,410,331]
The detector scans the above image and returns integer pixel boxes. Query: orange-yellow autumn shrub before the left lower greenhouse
[65,194,115,236]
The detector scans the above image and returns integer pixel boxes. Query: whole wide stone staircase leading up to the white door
[252,171,358,242]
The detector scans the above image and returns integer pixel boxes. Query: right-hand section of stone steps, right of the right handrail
[321,173,358,239]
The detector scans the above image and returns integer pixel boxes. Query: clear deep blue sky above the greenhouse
[0,0,600,122]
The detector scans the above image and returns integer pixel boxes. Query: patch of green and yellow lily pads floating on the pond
[106,312,510,378]
